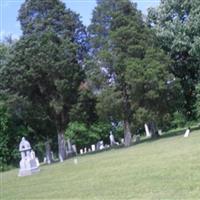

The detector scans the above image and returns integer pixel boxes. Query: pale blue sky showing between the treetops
[0,0,160,40]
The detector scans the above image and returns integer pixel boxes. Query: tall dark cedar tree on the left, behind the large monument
[0,0,86,161]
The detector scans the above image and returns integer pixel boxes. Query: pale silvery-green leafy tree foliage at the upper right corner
[149,0,200,119]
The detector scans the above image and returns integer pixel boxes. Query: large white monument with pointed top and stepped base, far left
[18,137,40,176]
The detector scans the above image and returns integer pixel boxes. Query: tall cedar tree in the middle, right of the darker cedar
[88,0,179,146]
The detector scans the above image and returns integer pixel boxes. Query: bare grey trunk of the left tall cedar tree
[58,131,67,162]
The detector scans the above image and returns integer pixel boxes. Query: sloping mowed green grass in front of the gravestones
[0,131,200,200]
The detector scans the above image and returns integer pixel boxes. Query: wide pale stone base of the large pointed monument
[18,158,40,176]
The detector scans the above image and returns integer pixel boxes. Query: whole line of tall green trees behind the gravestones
[0,0,200,169]
